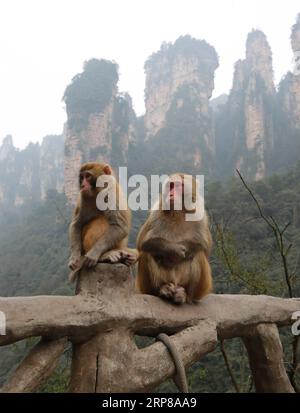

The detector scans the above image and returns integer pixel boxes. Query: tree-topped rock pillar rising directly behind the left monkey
[64,59,135,204]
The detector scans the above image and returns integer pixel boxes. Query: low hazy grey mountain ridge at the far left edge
[0,135,64,207]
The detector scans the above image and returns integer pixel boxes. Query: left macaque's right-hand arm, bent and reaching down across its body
[84,211,129,267]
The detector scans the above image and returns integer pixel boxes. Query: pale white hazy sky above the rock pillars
[0,0,300,147]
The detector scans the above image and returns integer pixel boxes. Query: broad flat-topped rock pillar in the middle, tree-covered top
[145,36,219,174]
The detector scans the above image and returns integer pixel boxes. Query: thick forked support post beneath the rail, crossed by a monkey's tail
[69,320,217,393]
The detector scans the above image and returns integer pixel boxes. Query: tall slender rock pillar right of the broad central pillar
[217,30,276,180]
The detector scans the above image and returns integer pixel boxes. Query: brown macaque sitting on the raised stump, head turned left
[69,162,136,281]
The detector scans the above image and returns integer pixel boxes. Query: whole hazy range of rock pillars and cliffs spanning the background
[0,15,300,205]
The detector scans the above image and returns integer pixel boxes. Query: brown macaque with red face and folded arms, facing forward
[137,173,212,304]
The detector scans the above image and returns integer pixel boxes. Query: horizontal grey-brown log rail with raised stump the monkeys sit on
[0,264,300,345]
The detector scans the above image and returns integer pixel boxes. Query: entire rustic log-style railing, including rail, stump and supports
[0,264,300,393]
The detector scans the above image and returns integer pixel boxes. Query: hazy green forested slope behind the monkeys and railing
[0,164,300,392]
